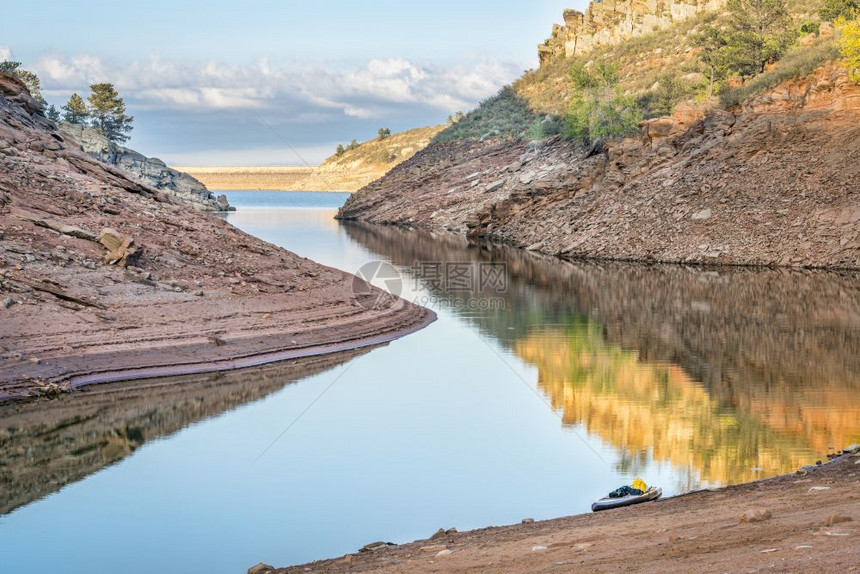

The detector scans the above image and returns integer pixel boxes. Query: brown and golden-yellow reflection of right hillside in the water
[346,223,860,487]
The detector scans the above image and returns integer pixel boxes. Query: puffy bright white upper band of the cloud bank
[35,55,519,119]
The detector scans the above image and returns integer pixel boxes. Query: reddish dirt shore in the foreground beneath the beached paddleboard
[277,452,860,574]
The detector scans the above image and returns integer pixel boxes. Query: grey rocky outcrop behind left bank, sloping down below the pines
[59,122,230,211]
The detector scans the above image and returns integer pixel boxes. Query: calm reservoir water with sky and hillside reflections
[0,192,860,573]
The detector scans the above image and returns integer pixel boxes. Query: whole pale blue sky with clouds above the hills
[0,0,587,165]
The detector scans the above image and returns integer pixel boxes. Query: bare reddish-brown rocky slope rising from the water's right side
[339,65,860,268]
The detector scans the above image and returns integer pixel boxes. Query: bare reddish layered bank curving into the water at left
[0,75,434,400]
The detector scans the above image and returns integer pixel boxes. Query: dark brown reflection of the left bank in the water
[0,349,371,515]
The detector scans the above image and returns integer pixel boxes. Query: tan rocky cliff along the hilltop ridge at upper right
[538,0,726,65]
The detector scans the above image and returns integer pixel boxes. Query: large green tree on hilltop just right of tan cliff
[722,0,794,76]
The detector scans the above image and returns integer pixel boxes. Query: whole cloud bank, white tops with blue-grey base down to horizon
[33,55,522,164]
